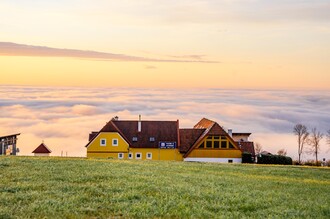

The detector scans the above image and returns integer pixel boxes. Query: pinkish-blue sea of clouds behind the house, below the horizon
[0,86,330,159]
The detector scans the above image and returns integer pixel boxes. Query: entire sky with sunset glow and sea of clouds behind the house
[0,0,330,160]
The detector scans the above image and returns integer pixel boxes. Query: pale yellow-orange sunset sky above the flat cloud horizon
[0,0,330,89]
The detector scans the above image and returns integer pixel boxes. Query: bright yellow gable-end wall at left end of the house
[87,132,129,158]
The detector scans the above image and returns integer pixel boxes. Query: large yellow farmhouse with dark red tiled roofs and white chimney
[86,118,253,163]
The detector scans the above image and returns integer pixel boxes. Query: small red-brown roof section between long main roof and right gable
[179,129,206,153]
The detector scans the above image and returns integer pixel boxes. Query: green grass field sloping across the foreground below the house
[0,157,330,218]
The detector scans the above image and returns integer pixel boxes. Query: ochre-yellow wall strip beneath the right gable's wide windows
[188,149,242,158]
